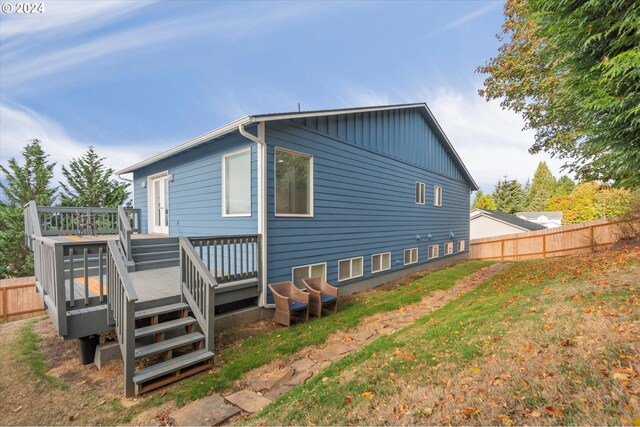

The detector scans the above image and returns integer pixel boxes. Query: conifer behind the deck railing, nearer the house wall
[60,147,129,208]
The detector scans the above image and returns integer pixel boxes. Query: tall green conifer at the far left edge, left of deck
[0,139,57,277]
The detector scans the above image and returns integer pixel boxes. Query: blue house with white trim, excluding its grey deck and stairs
[118,103,478,307]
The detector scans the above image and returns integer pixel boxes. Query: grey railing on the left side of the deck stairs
[107,240,138,397]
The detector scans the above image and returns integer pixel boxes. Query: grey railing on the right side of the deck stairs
[179,237,218,352]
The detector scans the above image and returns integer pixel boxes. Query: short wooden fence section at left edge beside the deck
[0,277,46,322]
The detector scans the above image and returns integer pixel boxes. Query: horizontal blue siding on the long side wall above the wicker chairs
[266,121,471,294]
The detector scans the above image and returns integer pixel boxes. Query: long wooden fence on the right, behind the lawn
[471,219,632,261]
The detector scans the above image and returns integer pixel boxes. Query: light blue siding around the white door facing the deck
[133,132,258,237]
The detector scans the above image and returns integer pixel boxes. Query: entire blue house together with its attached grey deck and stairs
[24,103,478,396]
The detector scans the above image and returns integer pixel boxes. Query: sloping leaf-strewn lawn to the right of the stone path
[246,251,640,425]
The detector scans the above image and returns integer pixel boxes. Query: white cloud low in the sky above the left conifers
[0,104,175,186]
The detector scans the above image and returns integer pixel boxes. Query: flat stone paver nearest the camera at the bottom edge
[171,394,240,426]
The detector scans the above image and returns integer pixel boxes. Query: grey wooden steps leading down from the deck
[133,303,213,394]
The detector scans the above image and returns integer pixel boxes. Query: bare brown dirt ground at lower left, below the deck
[0,318,122,425]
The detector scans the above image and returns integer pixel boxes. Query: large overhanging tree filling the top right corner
[478,0,640,188]
